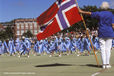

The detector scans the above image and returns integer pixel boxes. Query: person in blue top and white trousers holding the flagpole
[79,2,114,69]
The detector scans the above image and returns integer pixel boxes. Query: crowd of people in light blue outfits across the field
[0,30,114,57]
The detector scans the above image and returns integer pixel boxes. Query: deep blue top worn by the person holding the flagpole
[91,11,114,38]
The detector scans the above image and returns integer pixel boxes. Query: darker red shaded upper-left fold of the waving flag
[37,0,61,26]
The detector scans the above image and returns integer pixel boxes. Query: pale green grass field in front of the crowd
[0,49,114,76]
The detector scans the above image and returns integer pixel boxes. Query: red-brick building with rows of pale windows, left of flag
[14,19,39,37]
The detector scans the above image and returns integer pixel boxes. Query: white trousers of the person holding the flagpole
[99,38,112,64]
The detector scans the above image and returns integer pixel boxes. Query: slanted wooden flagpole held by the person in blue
[75,0,99,67]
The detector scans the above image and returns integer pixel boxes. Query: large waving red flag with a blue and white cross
[37,0,82,40]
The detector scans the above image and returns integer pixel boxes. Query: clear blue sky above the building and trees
[0,0,114,22]
